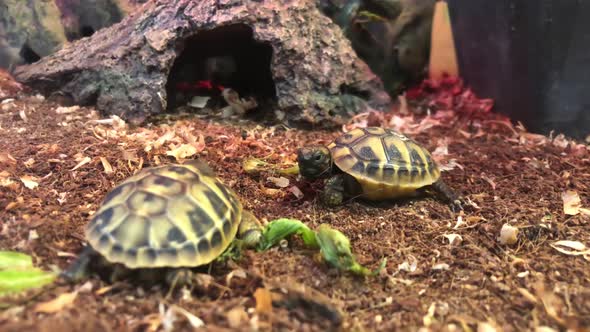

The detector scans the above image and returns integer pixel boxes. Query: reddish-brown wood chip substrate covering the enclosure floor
[0,89,590,332]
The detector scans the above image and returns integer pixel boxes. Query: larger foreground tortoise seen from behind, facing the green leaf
[63,161,261,285]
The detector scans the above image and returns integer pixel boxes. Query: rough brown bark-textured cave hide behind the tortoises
[15,0,390,127]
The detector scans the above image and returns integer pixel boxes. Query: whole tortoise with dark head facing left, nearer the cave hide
[297,127,460,208]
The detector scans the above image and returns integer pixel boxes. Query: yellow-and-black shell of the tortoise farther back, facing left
[328,127,440,200]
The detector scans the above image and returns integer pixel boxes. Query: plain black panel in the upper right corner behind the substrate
[448,0,590,138]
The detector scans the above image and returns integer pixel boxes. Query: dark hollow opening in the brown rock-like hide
[166,24,276,113]
